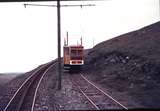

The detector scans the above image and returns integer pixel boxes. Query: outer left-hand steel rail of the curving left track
[3,61,54,111]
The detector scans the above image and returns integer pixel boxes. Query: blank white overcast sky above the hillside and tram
[0,0,160,73]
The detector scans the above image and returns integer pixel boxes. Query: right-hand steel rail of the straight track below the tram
[80,74,128,110]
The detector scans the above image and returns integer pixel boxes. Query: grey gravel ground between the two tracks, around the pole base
[29,64,96,111]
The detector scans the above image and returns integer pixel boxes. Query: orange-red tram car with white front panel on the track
[63,33,84,69]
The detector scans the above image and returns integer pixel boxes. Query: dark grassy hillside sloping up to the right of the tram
[84,22,160,108]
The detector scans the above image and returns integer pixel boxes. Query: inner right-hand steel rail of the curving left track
[31,63,56,111]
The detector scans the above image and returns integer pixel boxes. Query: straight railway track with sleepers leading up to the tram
[71,74,128,110]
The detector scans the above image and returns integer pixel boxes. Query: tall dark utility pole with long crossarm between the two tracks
[24,0,95,90]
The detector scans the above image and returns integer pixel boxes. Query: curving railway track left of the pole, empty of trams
[3,61,56,111]
